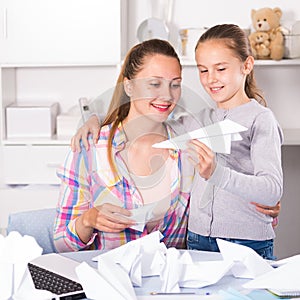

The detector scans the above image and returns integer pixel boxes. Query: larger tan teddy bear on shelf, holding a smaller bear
[250,7,284,60]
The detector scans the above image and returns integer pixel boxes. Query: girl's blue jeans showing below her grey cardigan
[187,230,276,260]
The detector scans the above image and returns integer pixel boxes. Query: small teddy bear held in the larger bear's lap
[249,31,271,59]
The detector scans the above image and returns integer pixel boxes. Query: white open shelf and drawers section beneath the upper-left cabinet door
[0,63,120,232]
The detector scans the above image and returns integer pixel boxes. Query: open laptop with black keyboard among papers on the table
[28,253,86,300]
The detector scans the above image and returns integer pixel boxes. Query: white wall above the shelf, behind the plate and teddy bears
[128,0,300,46]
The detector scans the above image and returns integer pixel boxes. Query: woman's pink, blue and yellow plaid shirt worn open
[54,124,194,252]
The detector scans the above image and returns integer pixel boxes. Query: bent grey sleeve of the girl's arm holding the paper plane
[208,112,283,206]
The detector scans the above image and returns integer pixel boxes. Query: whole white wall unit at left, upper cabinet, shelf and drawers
[0,0,127,232]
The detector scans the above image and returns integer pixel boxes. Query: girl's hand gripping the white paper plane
[188,140,216,180]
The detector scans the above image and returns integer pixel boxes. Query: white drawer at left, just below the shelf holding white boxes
[3,145,69,184]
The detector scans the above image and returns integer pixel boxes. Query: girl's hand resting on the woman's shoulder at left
[71,115,100,152]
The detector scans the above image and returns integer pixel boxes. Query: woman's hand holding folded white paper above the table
[76,203,135,243]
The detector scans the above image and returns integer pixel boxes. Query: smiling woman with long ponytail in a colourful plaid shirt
[54,39,194,252]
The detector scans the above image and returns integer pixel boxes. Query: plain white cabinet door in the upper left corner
[0,0,121,65]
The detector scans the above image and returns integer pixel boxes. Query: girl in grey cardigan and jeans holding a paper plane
[186,24,283,259]
